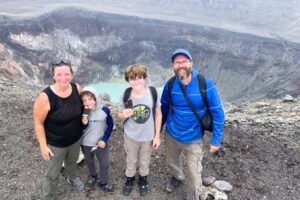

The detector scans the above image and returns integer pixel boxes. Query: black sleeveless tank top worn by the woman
[43,83,82,147]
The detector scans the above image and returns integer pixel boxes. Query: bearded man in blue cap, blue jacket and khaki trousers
[161,49,224,200]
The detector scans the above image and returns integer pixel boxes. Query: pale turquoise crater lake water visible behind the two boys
[90,82,162,103]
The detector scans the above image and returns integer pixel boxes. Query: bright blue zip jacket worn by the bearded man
[161,69,224,146]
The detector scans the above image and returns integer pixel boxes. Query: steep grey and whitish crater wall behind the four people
[0,6,300,103]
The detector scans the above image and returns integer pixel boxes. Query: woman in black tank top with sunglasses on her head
[33,61,84,199]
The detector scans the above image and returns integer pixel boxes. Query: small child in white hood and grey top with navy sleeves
[80,87,115,192]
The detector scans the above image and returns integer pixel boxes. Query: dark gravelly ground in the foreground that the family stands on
[0,75,300,200]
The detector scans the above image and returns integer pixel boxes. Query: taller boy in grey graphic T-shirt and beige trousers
[118,65,162,196]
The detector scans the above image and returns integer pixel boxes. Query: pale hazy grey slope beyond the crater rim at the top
[0,0,300,43]
